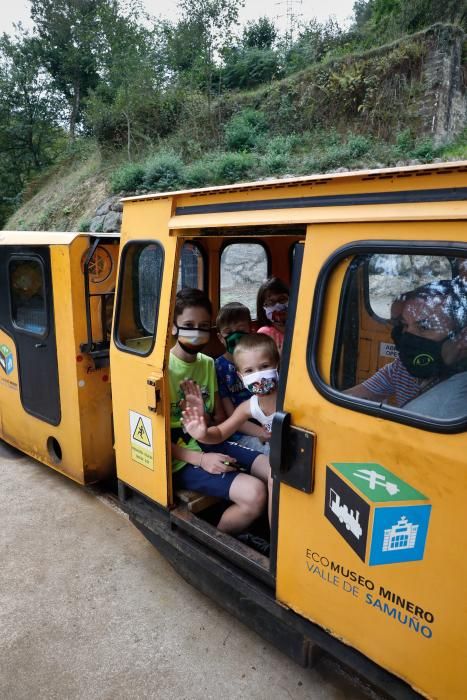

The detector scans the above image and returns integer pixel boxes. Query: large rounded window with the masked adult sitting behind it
[310,253,467,429]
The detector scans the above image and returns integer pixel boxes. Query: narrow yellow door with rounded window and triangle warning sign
[110,221,177,505]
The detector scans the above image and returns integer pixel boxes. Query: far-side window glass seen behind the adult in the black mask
[368,253,452,320]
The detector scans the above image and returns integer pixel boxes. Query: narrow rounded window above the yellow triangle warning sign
[116,243,164,355]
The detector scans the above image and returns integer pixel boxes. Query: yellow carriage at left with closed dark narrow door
[0,232,119,484]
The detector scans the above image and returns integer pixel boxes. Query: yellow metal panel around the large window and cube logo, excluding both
[277,222,467,698]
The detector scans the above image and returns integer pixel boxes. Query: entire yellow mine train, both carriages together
[0,162,467,699]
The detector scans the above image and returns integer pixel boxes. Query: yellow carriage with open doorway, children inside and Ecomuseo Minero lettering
[111,163,467,698]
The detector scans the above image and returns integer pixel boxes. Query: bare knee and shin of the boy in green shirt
[217,474,266,534]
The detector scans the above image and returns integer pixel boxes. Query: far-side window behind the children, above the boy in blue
[220,242,269,318]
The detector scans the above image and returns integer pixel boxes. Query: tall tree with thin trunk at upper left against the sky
[31,0,109,137]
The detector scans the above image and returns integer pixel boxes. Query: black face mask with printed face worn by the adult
[391,325,449,379]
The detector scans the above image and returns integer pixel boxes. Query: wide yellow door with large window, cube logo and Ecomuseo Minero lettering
[271,222,467,697]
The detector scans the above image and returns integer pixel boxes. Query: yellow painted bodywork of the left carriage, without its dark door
[0,233,117,484]
